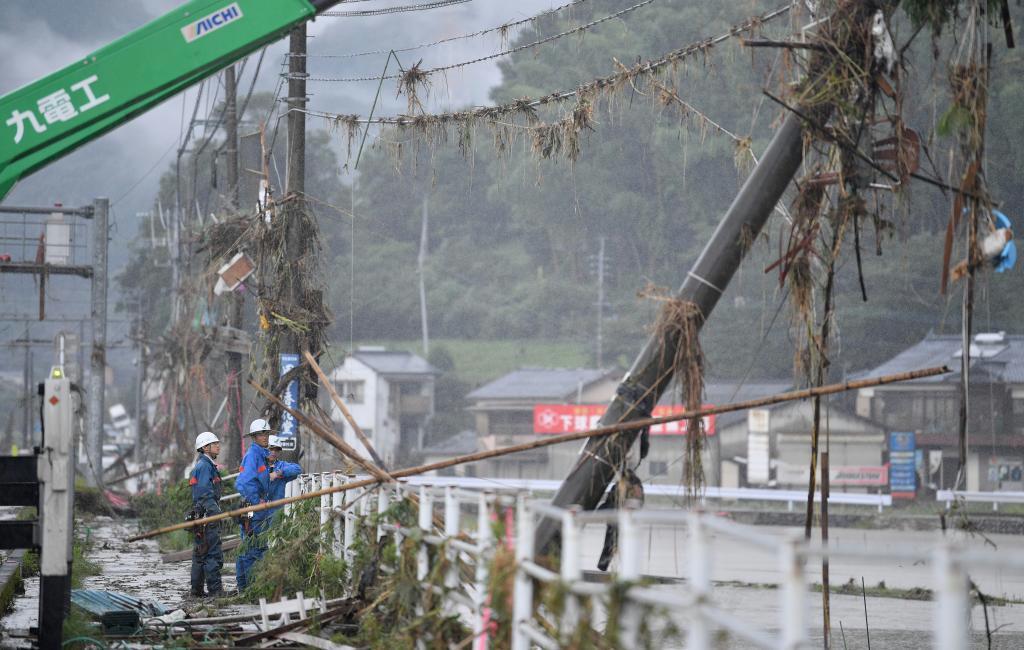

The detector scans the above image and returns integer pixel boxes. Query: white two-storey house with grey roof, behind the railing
[330,347,439,467]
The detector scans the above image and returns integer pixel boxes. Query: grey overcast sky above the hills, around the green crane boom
[0,0,564,234]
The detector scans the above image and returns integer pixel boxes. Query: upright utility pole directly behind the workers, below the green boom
[222,63,245,467]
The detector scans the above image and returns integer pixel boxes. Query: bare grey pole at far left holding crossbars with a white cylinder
[86,199,111,485]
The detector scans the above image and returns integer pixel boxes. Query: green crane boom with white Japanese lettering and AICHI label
[0,0,340,200]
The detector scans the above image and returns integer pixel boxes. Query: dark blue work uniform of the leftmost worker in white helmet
[188,453,224,596]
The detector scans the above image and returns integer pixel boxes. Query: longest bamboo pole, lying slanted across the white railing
[128,365,949,541]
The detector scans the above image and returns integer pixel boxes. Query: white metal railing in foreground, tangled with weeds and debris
[289,472,1024,650]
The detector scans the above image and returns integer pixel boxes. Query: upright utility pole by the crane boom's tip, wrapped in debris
[274,23,305,457]
